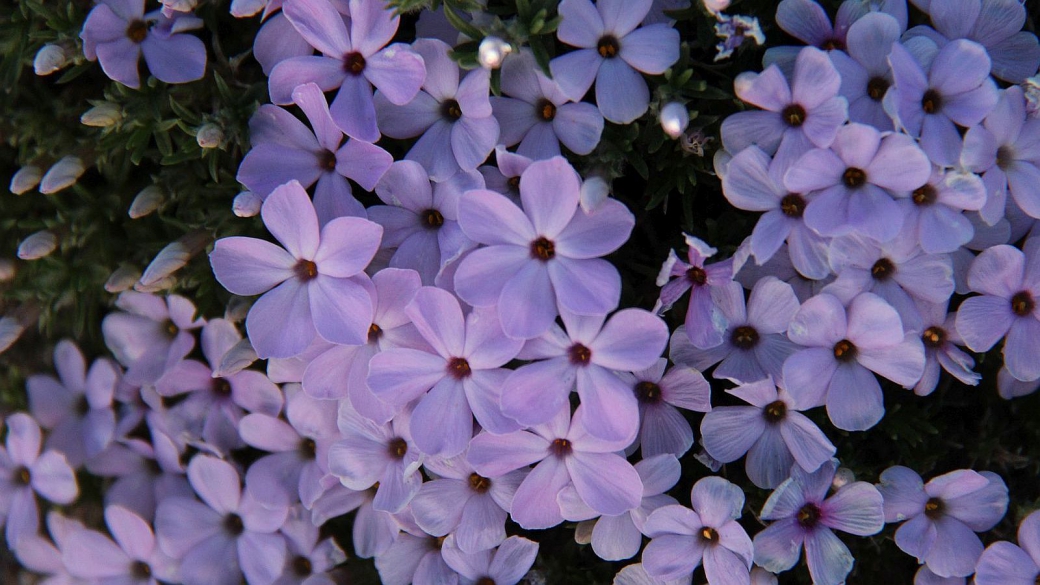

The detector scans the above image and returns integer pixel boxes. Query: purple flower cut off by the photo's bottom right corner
[974,512,1040,585]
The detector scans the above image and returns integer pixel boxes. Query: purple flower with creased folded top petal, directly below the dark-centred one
[701,379,836,489]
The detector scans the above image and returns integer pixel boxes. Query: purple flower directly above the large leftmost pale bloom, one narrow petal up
[236,83,393,221]
